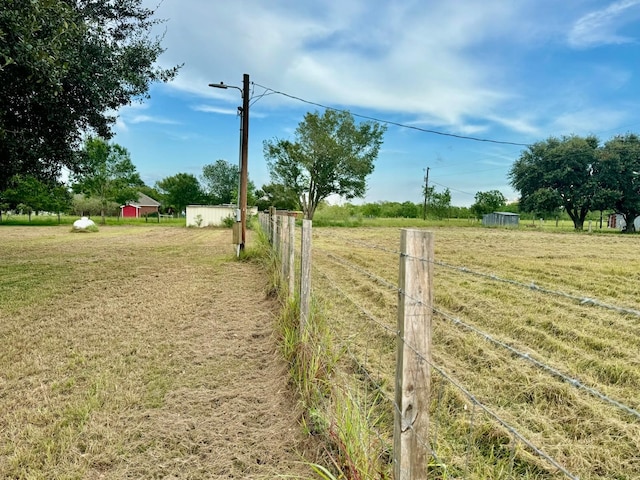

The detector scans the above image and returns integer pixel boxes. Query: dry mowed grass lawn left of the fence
[0,226,316,479]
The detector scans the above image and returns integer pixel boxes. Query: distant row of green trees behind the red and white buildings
[0,137,256,223]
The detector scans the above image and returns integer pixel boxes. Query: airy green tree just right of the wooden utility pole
[264,110,386,219]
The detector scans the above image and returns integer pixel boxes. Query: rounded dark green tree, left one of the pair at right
[509,135,599,230]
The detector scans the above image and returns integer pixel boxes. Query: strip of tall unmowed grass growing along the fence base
[258,230,391,480]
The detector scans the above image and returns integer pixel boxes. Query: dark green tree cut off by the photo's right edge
[596,133,640,233]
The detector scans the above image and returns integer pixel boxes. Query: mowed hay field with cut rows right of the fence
[313,227,640,480]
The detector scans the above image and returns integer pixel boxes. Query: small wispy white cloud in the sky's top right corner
[568,0,640,48]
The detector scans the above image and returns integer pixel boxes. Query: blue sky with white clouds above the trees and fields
[114,0,640,206]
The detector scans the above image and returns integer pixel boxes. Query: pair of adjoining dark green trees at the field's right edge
[509,133,640,232]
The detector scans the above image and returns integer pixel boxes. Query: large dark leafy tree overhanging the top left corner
[0,0,177,190]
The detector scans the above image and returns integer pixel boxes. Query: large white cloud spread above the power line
[148,0,532,129]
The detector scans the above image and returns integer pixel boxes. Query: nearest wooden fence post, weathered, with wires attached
[393,229,433,480]
